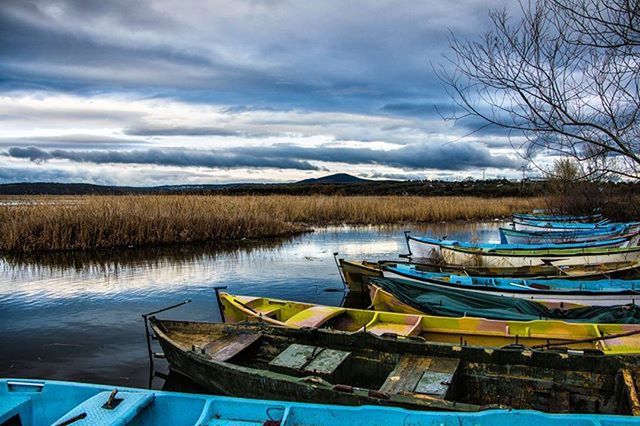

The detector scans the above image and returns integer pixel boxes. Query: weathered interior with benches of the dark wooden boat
[155,320,640,414]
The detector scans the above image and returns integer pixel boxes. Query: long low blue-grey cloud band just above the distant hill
[5,143,519,170]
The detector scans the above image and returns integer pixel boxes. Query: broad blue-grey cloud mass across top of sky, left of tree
[0,0,511,114]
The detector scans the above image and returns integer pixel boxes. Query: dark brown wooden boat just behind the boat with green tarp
[338,259,640,292]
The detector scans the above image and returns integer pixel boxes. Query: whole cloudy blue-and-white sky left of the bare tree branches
[0,0,522,185]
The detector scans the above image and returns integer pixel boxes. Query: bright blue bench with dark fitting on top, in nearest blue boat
[54,391,154,426]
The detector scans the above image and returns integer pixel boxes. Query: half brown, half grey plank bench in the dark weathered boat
[380,355,460,399]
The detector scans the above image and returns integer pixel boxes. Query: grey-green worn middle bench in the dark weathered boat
[269,343,351,382]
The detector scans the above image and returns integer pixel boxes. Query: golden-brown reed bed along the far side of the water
[0,195,541,252]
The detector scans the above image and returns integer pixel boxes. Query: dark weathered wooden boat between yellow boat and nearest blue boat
[151,318,638,414]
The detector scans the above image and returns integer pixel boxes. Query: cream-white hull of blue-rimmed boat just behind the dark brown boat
[407,236,640,268]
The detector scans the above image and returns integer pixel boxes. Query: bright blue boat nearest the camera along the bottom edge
[0,379,640,426]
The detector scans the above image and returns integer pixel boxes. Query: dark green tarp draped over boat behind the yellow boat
[370,278,640,324]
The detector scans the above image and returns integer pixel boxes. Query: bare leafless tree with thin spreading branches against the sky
[439,0,640,179]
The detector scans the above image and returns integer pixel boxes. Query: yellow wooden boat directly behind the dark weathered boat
[219,292,640,354]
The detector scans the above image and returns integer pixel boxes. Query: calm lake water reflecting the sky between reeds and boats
[0,222,499,391]
